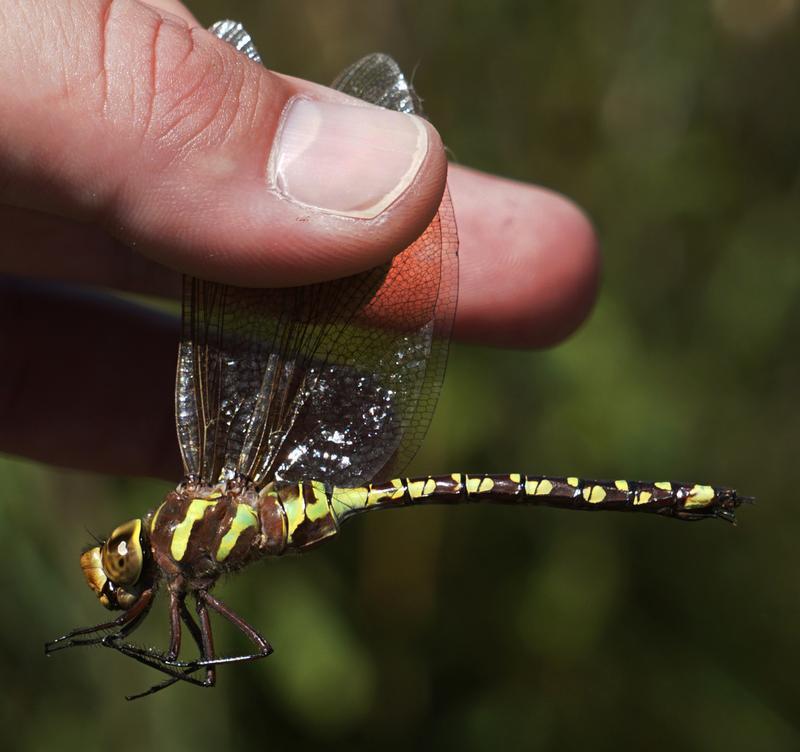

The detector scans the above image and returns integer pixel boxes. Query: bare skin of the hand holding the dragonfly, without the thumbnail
[0,0,599,479]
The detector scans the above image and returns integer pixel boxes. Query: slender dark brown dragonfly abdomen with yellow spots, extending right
[329,473,749,524]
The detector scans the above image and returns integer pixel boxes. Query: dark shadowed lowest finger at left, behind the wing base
[0,280,181,480]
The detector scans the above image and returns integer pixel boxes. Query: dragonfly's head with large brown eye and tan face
[81,519,148,611]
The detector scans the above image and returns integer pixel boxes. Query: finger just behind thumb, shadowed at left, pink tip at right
[0,167,600,347]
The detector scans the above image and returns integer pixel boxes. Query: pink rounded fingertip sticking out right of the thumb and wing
[448,167,600,347]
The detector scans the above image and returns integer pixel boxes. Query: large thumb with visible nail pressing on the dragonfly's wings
[0,0,447,286]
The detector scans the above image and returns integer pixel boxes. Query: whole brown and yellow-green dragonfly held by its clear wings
[45,21,749,699]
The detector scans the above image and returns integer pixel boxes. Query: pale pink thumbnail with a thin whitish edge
[270,98,428,219]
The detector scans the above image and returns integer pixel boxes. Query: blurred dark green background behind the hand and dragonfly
[0,0,800,752]
